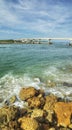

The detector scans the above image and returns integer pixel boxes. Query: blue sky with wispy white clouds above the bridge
[0,0,72,39]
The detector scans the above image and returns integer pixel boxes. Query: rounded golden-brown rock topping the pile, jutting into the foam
[19,87,38,101]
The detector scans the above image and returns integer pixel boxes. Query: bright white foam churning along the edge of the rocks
[0,72,72,107]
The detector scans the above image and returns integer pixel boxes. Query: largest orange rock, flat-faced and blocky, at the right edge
[54,102,72,127]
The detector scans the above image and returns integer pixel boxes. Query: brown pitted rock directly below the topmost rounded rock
[27,95,45,108]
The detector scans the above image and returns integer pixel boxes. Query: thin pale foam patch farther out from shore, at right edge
[43,66,72,83]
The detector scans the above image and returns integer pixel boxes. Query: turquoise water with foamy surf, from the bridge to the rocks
[0,42,72,104]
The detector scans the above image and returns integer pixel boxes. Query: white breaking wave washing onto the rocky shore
[0,71,72,106]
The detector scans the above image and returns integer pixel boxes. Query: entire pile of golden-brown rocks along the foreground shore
[0,87,72,130]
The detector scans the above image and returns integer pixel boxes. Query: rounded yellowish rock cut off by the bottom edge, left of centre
[18,117,40,130]
